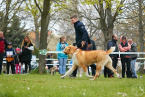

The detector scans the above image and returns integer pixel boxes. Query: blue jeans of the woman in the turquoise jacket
[58,58,67,74]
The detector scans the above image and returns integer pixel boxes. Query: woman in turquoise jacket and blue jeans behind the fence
[56,36,68,75]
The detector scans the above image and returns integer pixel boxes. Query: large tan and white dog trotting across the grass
[61,46,121,80]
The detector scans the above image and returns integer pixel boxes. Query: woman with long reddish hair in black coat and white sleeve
[21,36,34,73]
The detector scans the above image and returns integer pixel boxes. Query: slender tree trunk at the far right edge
[138,0,145,73]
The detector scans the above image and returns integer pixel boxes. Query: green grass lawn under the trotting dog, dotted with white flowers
[0,74,145,97]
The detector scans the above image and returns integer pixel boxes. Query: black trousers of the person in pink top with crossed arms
[121,58,131,78]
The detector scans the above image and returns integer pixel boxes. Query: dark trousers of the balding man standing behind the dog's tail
[104,57,118,77]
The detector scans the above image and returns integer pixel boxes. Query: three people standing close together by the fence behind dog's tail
[104,34,137,78]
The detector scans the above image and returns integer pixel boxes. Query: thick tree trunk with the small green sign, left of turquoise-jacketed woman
[39,0,51,74]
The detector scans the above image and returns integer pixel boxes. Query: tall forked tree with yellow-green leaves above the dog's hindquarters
[85,0,125,50]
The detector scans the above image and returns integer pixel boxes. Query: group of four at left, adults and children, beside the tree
[0,31,34,74]
